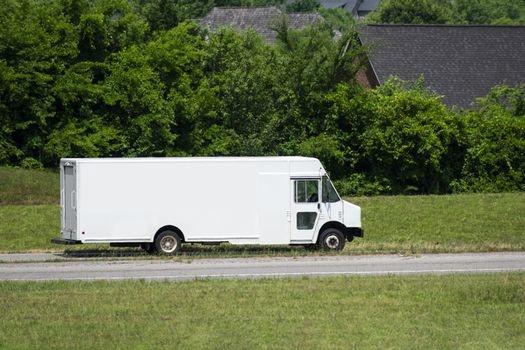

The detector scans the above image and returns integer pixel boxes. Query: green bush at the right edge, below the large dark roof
[453,86,525,192]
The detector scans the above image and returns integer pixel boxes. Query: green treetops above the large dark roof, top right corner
[366,0,525,25]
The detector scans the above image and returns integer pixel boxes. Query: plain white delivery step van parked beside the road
[53,157,363,254]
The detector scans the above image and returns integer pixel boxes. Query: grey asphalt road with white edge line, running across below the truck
[0,252,525,281]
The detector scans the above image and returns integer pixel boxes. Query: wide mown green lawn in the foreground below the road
[0,273,525,350]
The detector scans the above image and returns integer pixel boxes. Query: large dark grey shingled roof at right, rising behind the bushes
[360,25,525,108]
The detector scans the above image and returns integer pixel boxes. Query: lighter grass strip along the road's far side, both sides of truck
[0,193,525,257]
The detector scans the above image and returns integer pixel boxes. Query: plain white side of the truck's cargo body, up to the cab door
[78,160,296,244]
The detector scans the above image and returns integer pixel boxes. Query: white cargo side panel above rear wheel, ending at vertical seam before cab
[75,162,252,241]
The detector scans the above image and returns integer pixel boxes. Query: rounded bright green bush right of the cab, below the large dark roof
[361,80,459,193]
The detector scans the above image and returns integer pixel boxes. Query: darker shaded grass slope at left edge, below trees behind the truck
[0,167,60,205]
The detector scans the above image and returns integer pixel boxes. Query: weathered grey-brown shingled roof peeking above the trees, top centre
[200,7,322,43]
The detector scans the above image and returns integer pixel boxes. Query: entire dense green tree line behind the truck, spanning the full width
[0,0,525,194]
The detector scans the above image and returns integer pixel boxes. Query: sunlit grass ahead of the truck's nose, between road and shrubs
[350,193,525,253]
